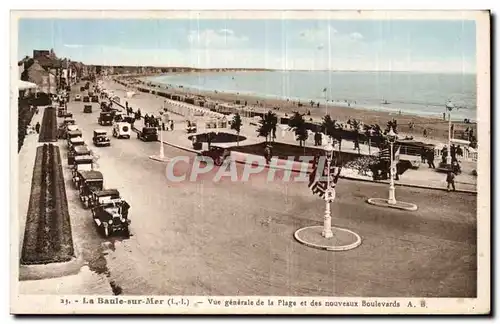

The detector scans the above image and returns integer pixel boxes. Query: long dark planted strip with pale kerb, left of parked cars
[20,144,80,279]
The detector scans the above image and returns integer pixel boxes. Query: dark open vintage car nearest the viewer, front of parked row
[90,189,130,237]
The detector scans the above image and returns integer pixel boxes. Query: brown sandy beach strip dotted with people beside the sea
[117,75,477,142]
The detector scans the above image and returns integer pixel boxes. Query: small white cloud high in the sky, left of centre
[188,29,248,48]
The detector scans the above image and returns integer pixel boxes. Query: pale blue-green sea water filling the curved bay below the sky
[147,71,477,120]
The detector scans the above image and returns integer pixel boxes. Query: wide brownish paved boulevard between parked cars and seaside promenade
[57,85,476,297]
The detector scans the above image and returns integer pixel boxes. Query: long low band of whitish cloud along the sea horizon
[75,47,475,72]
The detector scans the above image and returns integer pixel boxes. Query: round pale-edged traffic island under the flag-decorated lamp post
[294,226,361,251]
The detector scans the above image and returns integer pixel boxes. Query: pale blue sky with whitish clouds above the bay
[18,19,476,73]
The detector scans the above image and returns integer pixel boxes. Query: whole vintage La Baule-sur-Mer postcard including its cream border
[10,11,491,314]
